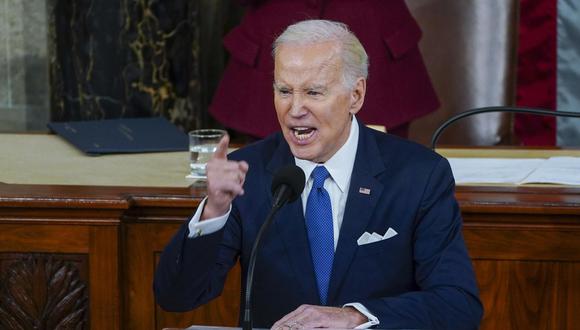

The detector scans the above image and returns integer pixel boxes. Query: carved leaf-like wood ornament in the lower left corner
[0,254,88,329]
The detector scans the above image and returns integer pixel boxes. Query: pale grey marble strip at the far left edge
[0,0,49,132]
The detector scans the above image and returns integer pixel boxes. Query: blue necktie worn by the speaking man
[305,166,334,305]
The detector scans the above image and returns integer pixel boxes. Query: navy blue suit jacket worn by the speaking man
[154,125,482,329]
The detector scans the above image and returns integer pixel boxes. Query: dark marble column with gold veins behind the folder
[47,0,203,130]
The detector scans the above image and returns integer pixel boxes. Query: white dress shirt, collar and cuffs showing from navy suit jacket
[189,116,379,329]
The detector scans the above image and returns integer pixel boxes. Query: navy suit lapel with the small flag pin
[328,125,385,303]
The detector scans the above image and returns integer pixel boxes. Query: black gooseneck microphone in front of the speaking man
[242,185,291,330]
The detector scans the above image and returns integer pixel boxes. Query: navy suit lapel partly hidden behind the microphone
[266,138,320,304]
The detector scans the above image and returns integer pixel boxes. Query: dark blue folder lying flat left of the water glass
[48,117,189,156]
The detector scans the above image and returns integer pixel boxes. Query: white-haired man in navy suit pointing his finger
[154,20,482,329]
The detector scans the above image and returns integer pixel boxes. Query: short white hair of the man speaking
[272,20,369,89]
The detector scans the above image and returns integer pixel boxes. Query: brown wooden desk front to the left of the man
[0,184,240,329]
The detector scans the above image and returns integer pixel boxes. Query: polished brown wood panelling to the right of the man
[457,187,580,329]
